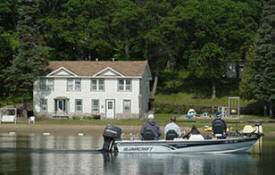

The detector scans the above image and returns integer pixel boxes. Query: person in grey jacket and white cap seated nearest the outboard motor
[140,114,161,140]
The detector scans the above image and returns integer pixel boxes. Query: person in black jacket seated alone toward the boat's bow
[212,113,227,138]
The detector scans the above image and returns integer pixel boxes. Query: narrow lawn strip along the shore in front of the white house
[1,114,275,133]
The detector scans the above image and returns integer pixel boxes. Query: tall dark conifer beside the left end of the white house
[5,0,47,116]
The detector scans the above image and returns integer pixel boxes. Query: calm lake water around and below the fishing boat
[0,133,275,175]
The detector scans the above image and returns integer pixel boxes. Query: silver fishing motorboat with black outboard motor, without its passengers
[103,125,261,153]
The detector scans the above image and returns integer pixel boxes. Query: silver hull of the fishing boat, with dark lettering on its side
[116,137,258,153]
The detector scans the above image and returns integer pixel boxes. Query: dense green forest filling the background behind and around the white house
[0,0,275,116]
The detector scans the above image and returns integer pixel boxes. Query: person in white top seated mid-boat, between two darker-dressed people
[164,117,181,140]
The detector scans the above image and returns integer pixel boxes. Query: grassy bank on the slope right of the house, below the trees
[155,92,255,107]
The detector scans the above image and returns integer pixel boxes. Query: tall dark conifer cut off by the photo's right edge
[255,0,275,117]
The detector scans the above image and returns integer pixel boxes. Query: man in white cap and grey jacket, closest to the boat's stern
[140,114,161,140]
